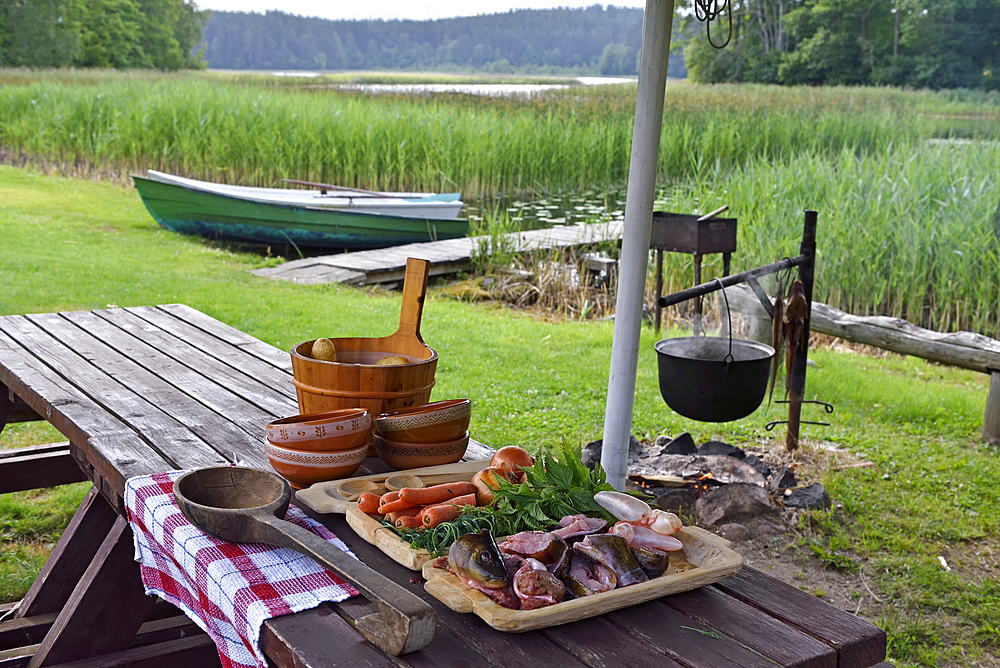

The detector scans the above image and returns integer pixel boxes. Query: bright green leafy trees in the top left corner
[0,0,208,71]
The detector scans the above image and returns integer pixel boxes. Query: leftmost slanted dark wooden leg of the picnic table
[17,487,118,617]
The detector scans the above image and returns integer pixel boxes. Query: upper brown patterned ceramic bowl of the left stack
[267,408,372,452]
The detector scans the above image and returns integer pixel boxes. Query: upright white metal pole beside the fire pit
[601,0,674,490]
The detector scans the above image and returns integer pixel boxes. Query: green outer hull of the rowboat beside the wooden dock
[132,176,469,249]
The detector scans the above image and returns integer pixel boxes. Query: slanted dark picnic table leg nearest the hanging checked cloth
[28,516,155,668]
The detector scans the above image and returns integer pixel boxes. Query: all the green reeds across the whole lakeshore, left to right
[0,70,1000,336]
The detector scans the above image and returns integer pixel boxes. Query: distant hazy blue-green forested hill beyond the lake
[199,5,660,75]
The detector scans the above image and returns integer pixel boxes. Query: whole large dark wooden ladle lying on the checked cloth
[174,466,437,655]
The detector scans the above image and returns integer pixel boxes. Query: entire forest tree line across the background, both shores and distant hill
[0,0,1000,90]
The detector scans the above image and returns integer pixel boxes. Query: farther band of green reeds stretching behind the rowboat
[0,71,948,197]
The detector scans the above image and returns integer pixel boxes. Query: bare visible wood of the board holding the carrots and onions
[295,460,489,571]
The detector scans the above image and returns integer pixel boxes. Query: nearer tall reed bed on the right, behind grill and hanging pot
[664,142,1000,338]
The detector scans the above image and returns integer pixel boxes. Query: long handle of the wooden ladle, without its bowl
[259,515,437,656]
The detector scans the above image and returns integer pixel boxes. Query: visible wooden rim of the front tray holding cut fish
[423,527,743,633]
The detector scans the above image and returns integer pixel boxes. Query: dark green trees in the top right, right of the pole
[685,0,1000,90]
